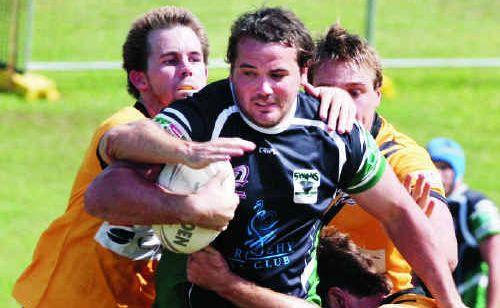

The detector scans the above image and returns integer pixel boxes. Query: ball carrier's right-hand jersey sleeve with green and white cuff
[339,124,387,193]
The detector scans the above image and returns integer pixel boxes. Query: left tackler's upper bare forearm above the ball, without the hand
[99,120,188,164]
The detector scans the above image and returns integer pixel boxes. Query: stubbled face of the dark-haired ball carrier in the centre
[231,38,305,127]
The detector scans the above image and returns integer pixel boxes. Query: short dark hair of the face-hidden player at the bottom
[318,227,391,301]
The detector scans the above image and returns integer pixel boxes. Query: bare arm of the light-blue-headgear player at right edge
[479,234,500,308]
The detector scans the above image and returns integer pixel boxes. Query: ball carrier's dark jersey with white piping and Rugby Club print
[156,80,385,306]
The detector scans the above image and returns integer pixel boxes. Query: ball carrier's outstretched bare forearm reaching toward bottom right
[384,196,461,307]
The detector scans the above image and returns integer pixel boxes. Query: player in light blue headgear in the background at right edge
[427,138,500,308]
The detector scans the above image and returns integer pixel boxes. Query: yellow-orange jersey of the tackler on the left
[13,103,159,307]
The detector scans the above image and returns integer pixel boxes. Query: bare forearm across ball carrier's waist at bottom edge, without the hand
[217,275,318,308]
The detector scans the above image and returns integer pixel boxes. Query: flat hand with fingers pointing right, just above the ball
[184,138,255,168]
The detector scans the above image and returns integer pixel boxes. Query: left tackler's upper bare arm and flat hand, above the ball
[99,120,255,168]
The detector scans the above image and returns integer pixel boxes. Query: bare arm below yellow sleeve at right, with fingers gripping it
[403,174,458,271]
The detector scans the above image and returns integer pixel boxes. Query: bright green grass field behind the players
[0,0,500,307]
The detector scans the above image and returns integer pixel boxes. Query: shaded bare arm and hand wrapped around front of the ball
[85,161,239,230]
